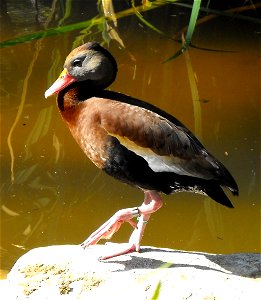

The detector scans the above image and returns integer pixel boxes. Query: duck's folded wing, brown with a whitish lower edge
[101,102,223,179]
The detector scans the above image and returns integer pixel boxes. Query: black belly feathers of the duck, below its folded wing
[103,138,204,194]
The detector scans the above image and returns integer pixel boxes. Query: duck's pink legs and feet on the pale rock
[81,191,163,260]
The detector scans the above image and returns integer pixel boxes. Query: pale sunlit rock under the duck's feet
[0,245,261,300]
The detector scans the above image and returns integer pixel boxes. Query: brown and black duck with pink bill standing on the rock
[45,42,238,259]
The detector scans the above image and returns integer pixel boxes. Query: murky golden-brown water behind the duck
[0,1,260,278]
